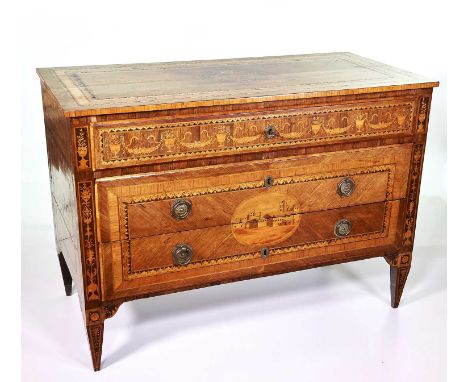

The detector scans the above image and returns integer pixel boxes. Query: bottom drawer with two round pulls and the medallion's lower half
[100,200,405,300]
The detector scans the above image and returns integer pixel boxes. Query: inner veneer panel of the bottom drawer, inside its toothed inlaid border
[122,202,391,275]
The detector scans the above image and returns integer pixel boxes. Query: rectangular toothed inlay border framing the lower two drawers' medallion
[120,165,394,278]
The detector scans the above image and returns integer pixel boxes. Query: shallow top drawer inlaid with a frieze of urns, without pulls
[92,98,417,169]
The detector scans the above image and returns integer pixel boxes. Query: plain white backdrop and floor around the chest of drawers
[21,1,448,381]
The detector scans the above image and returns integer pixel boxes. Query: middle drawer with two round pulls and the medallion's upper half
[96,144,411,242]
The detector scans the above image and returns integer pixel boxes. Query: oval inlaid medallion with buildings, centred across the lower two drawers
[231,192,301,245]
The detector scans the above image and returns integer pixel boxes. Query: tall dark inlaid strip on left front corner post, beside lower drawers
[78,181,100,301]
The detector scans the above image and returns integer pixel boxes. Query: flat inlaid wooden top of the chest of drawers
[37,53,439,117]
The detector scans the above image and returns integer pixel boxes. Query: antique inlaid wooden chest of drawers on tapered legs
[38,53,438,370]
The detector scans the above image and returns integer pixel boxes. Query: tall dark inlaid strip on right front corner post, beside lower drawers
[403,144,424,245]
